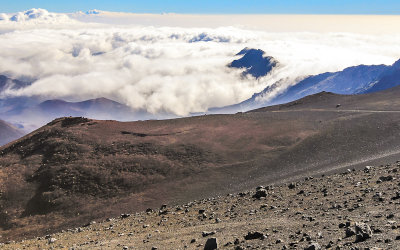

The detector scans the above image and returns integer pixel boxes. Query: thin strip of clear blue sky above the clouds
[0,0,400,15]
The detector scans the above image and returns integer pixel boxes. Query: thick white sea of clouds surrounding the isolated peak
[0,9,400,116]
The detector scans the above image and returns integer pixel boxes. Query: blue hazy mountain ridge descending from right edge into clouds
[214,60,400,113]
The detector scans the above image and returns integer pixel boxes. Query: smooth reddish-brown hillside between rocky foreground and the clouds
[0,88,400,238]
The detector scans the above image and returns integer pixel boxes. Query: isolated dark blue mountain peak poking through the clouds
[228,47,278,78]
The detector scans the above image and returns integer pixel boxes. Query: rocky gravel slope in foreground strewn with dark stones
[2,161,400,249]
